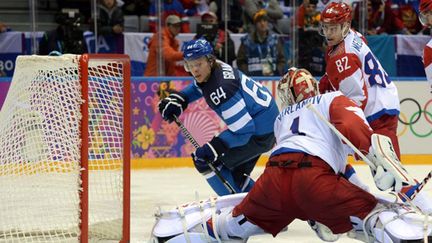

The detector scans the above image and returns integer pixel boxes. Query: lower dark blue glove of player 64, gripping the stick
[191,137,228,174]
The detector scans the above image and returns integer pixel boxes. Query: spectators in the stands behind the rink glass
[0,0,429,76]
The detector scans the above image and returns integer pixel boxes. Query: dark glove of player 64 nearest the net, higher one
[159,92,188,123]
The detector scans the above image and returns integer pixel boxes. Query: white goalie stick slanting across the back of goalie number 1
[306,103,432,200]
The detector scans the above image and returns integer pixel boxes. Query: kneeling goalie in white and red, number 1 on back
[153,68,432,243]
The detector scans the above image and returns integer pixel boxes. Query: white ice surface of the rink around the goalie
[131,165,432,243]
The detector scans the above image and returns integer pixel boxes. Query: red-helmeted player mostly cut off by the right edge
[419,0,432,93]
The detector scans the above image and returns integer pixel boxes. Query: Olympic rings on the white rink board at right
[397,98,432,138]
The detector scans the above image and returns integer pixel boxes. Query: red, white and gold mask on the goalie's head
[278,67,319,107]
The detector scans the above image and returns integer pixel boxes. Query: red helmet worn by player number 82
[321,2,352,24]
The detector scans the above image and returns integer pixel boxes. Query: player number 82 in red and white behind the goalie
[319,2,400,158]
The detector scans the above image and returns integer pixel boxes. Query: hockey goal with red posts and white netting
[0,54,130,242]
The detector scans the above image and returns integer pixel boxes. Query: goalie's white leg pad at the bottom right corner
[348,203,432,243]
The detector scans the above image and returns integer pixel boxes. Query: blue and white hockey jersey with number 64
[181,60,279,148]
